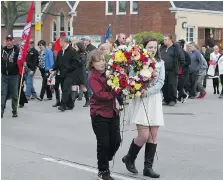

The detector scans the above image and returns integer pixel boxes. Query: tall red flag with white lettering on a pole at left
[17,1,35,75]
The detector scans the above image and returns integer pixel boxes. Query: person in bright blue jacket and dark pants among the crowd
[37,40,54,101]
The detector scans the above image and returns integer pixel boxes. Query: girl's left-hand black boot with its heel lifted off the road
[122,139,142,174]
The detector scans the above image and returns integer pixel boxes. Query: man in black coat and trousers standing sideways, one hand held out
[50,36,78,111]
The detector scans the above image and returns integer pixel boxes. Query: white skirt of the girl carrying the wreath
[128,93,164,126]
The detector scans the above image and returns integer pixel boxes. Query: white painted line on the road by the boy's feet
[43,157,136,180]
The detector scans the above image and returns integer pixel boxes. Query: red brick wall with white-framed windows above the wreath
[74,1,176,40]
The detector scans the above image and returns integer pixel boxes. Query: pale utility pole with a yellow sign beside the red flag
[35,1,42,45]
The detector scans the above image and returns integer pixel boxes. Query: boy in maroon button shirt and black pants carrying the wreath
[88,49,121,180]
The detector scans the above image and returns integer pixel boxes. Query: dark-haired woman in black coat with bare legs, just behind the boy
[72,42,89,107]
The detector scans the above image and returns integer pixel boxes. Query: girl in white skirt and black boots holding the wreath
[122,37,165,178]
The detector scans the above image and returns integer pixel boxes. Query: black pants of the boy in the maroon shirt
[91,114,121,171]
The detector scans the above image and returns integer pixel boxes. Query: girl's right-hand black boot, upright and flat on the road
[143,143,160,178]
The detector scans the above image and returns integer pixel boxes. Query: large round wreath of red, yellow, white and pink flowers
[106,45,157,97]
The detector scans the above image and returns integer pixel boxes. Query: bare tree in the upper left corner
[1,1,30,34]
